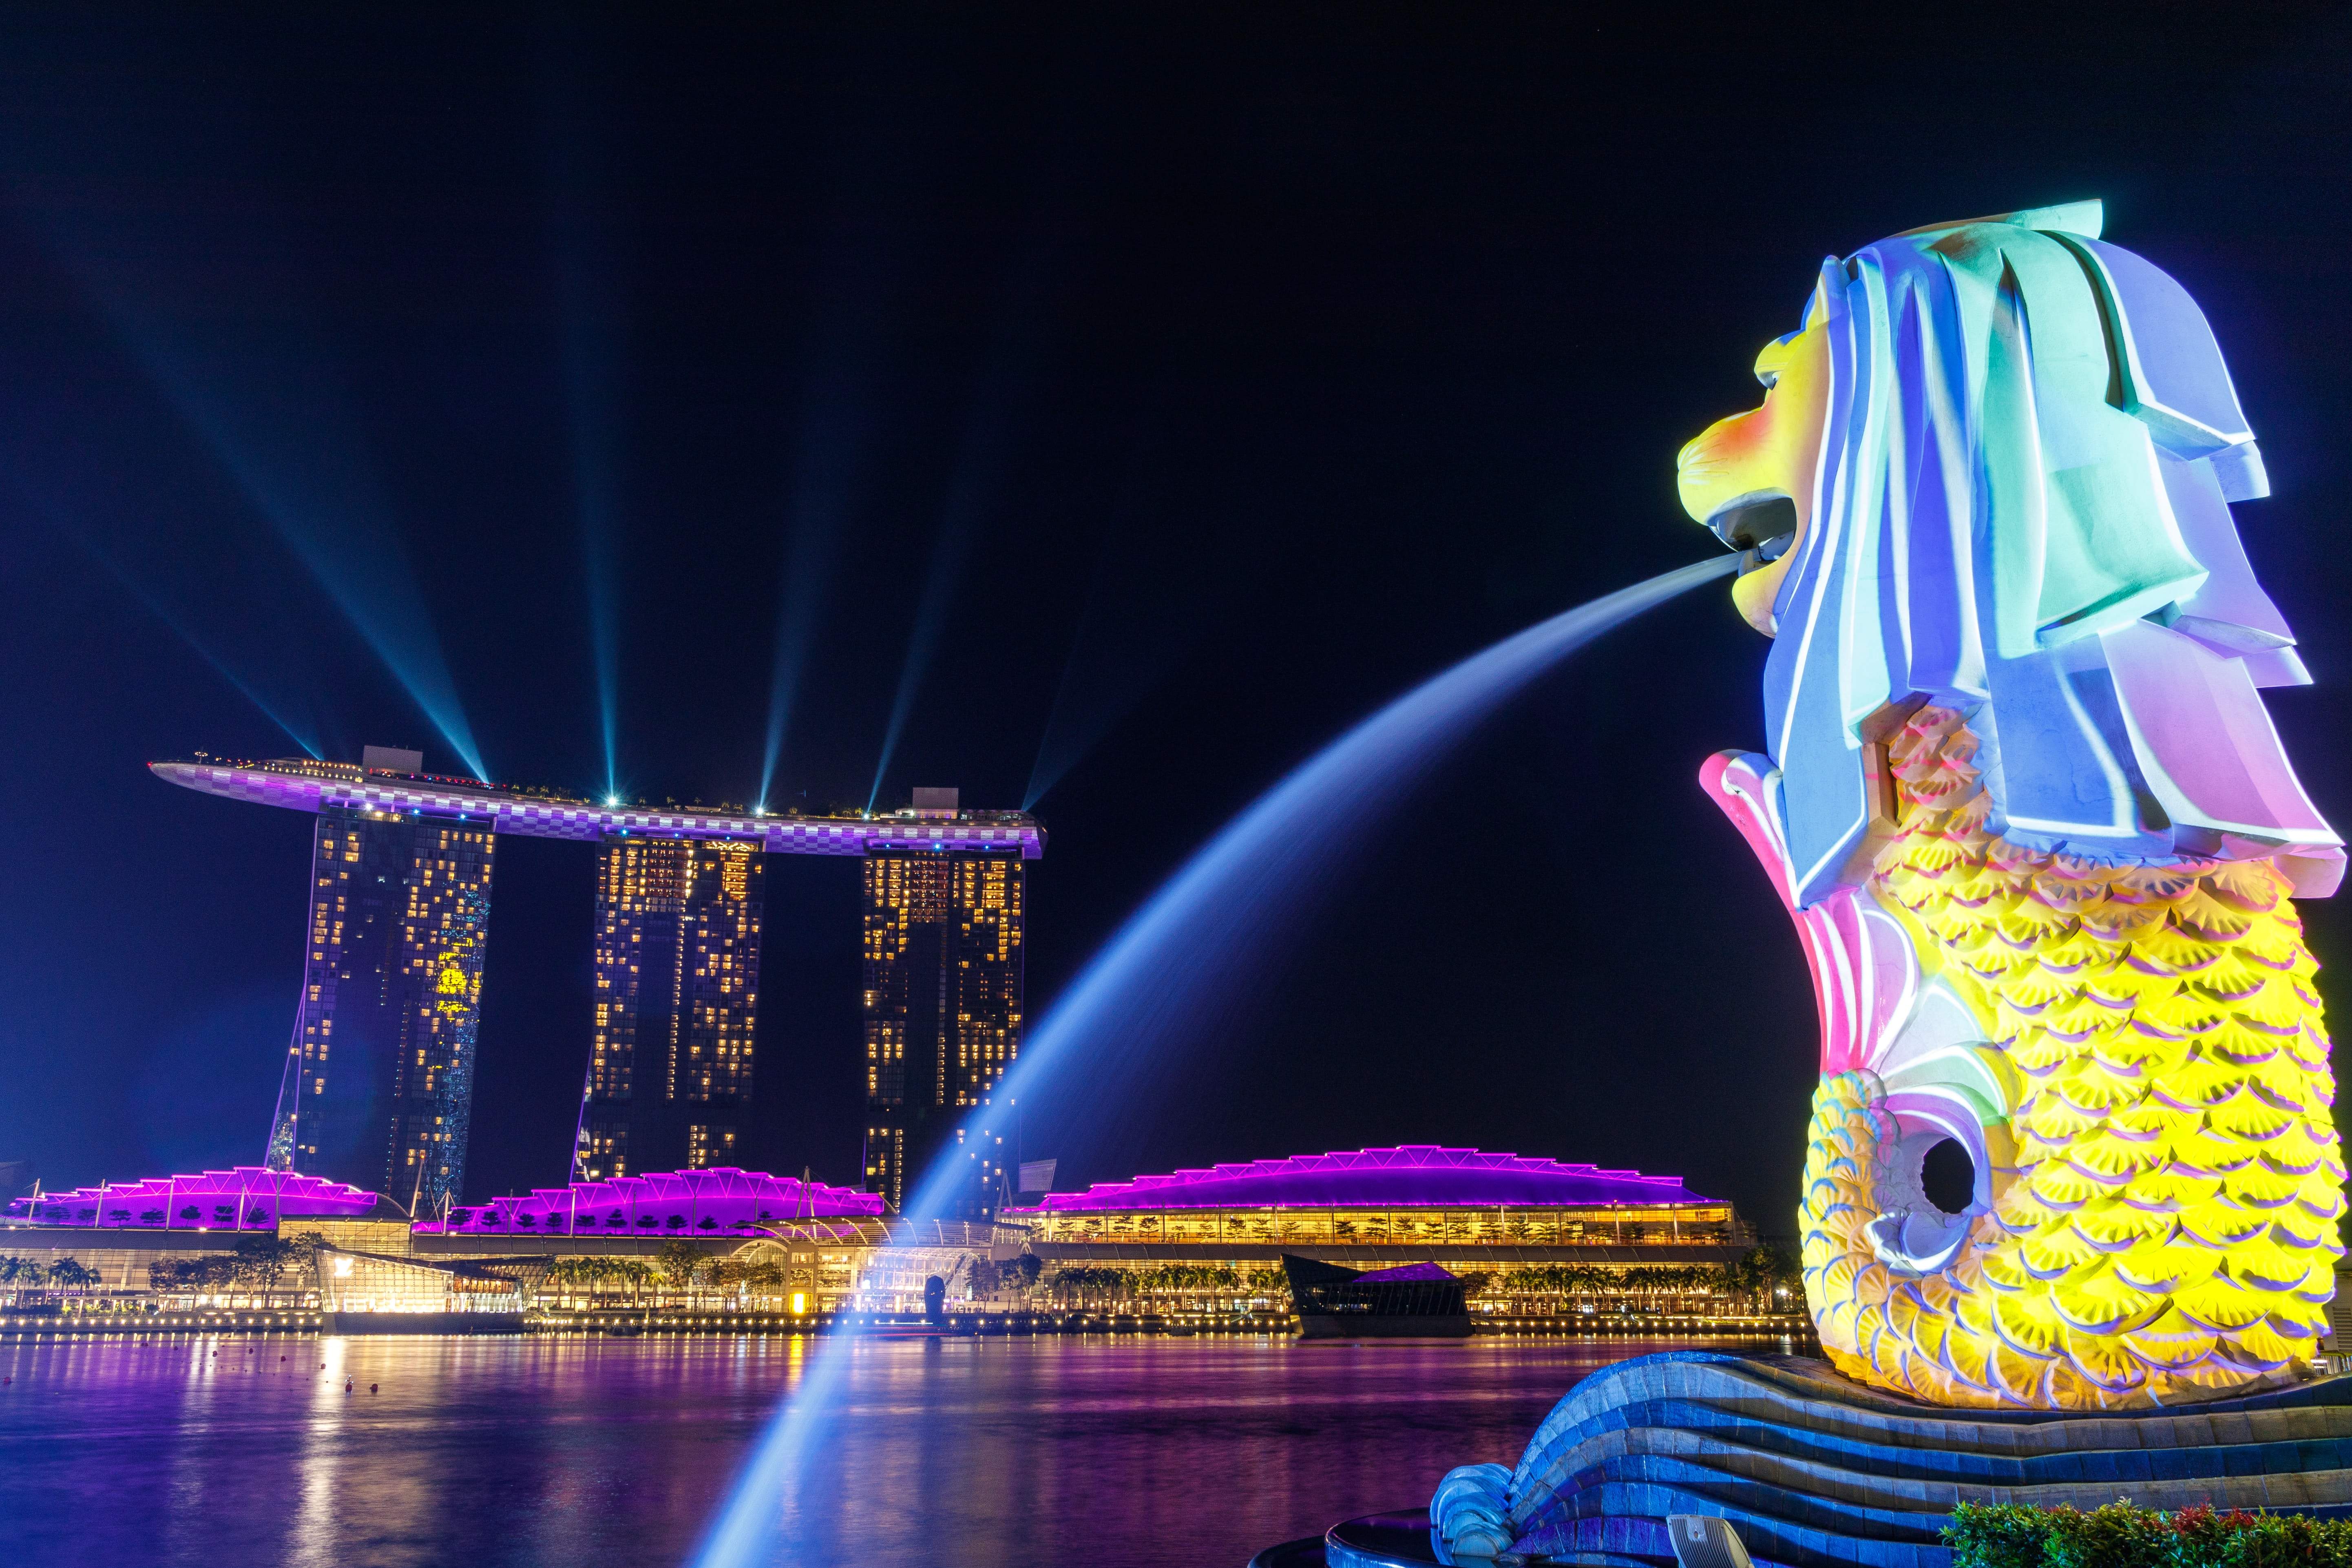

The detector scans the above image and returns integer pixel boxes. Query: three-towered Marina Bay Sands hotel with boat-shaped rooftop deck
[148,745,1044,1218]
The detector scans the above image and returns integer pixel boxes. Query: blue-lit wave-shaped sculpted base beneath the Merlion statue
[1284,1352,2352,1568]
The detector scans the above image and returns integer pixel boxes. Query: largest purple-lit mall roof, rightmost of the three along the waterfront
[1004,1143,1717,1215]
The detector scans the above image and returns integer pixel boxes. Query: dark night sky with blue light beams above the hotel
[0,5,2352,1232]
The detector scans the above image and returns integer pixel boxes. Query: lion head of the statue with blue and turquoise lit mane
[1679,202,2343,905]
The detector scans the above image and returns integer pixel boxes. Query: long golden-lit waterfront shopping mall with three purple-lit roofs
[0,1145,1769,1323]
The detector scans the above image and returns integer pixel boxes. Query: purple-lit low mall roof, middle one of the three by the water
[416,1166,882,1236]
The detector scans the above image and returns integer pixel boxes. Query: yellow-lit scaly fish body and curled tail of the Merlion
[1799,708,2345,1411]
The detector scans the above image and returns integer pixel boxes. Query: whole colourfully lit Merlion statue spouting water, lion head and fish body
[1679,202,2345,1411]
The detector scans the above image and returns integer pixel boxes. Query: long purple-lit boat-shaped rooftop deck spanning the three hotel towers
[148,757,1044,860]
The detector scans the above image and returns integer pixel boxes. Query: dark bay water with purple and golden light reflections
[0,1338,1778,1568]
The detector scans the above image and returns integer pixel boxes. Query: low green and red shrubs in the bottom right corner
[1943,1502,2352,1568]
